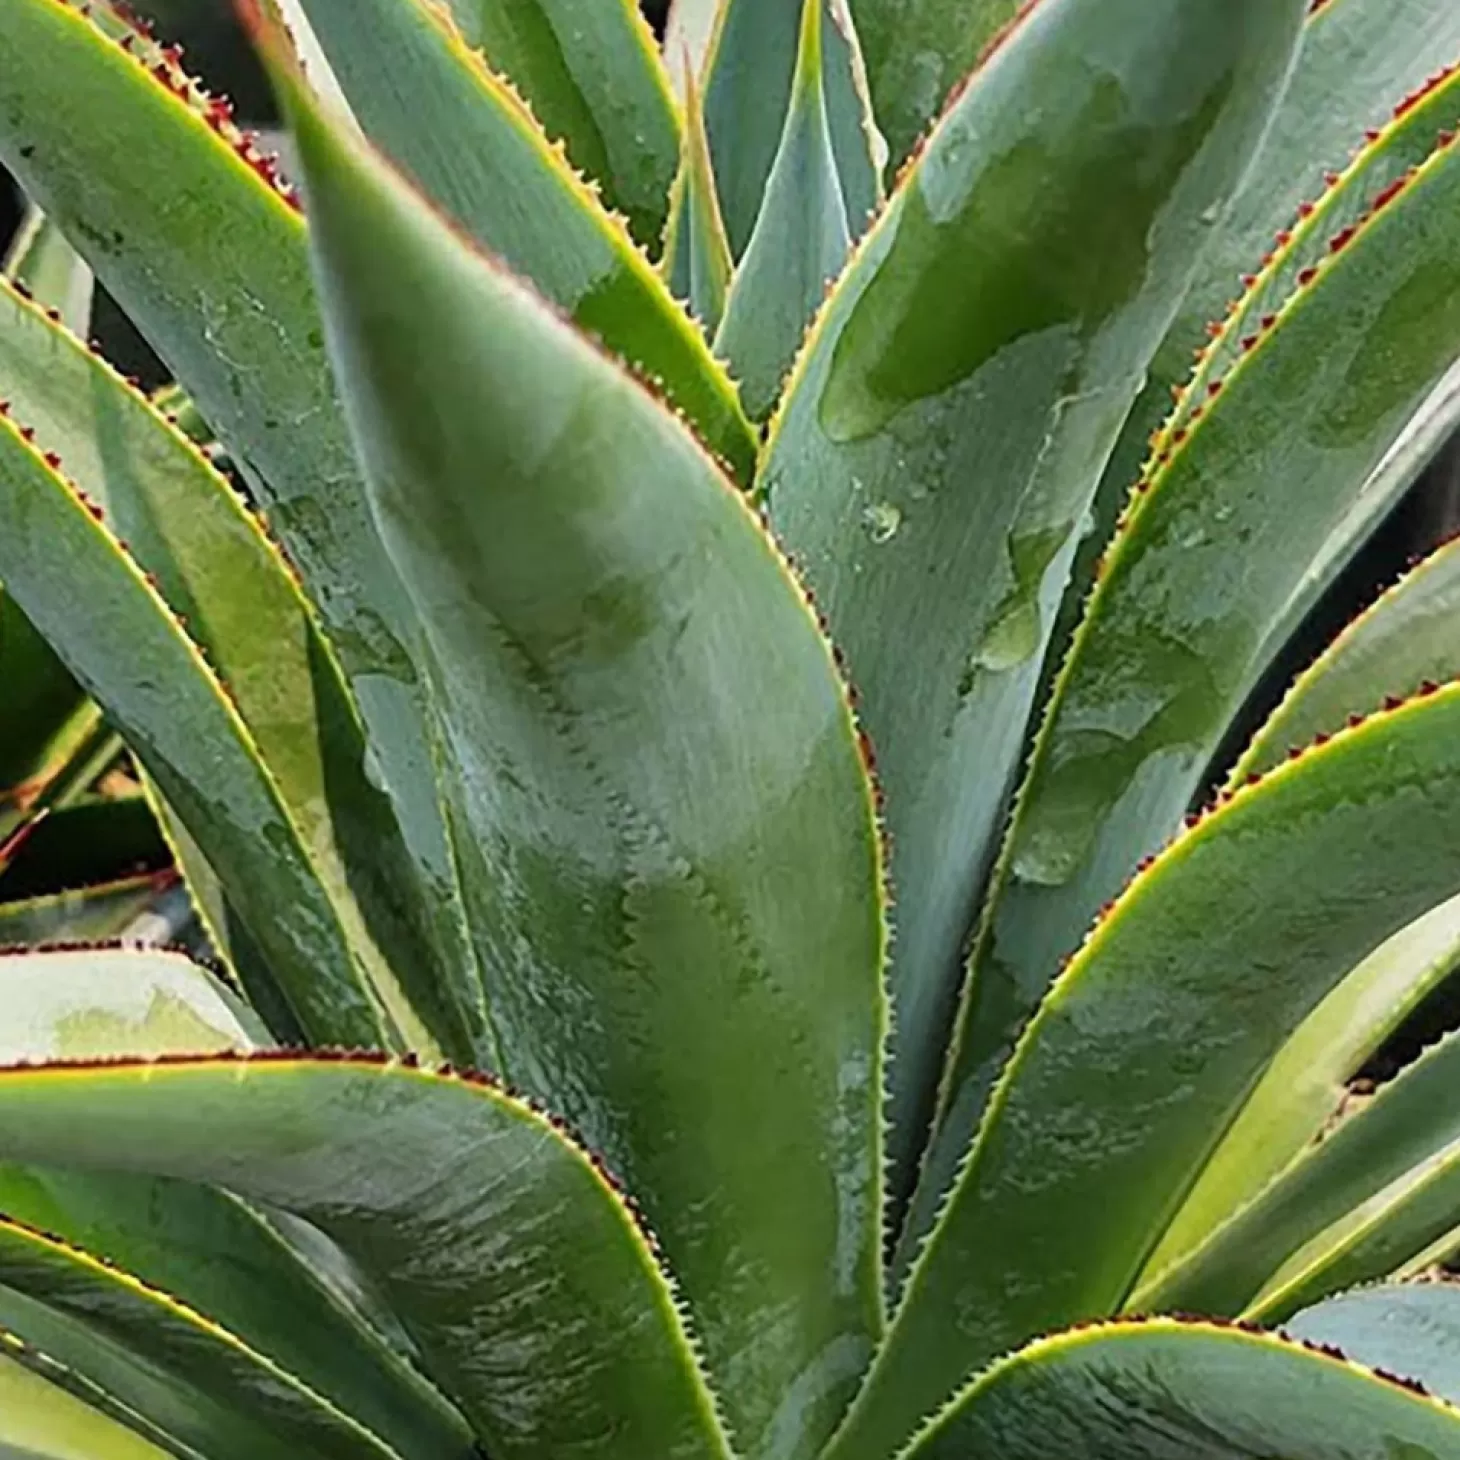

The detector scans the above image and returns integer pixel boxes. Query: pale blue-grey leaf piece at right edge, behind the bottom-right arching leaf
[1283,1283,1460,1405]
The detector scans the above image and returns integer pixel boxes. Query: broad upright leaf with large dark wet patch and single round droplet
[761,0,1302,1190]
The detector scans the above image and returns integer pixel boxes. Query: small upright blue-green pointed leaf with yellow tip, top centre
[715,0,851,420]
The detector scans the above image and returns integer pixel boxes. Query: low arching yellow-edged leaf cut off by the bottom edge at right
[907,1318,1460,1460]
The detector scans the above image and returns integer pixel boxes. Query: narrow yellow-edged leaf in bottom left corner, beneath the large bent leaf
[0,1218,414,1460]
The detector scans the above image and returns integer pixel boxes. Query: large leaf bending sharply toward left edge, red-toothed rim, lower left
[0,1056,729,1460]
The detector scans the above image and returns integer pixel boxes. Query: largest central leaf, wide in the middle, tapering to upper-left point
[271,37,883,1457]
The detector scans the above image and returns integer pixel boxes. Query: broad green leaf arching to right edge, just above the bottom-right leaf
[829,685,1460,1456]
